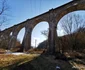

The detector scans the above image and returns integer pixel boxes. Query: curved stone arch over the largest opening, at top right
[54,0,85,52]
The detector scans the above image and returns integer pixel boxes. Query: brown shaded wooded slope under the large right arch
[56,28,85,52]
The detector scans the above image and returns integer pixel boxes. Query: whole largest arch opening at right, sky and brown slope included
[57,10,85,52]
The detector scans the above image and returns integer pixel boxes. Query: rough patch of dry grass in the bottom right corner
[65,52,85,70]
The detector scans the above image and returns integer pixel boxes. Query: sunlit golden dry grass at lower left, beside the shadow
[0,54,37,68]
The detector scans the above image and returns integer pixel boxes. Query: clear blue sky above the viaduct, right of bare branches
[2,0,71,29]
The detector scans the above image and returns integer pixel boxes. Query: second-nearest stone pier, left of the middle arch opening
[23,28,31,52]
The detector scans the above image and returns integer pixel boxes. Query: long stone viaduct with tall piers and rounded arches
[0,0,85,54]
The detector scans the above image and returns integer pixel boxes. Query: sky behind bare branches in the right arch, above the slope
[57,10,85,36]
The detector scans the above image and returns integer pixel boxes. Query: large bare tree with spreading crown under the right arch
[60,13,85,51]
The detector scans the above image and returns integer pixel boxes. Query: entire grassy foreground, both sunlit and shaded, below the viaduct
[0,51,85,70]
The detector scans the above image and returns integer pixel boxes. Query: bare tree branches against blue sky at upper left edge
[0,0,9,29]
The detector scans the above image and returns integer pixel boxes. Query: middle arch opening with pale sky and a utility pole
[31,21,49,49]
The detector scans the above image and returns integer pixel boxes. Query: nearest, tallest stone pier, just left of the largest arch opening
[48,18,57,54]
